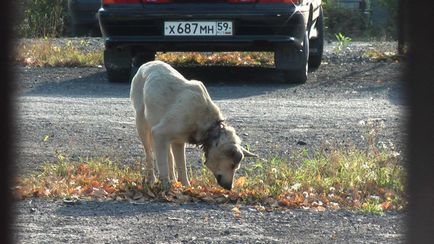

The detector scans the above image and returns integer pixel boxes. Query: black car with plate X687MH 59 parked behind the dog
[98,0,323,82]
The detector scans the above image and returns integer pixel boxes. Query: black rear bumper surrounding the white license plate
[98,4,309,51]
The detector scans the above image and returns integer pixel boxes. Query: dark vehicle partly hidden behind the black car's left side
[68,0,101,36]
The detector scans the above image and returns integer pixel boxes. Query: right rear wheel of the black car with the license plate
[274,32,309,83]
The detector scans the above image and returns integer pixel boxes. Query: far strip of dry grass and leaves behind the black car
[14,38,399,67]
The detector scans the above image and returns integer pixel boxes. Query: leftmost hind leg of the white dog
[136,110,156,184]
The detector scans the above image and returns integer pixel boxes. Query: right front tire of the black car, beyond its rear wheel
[309,7,324,69]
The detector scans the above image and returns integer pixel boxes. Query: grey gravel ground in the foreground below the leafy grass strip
[15,200,405,243]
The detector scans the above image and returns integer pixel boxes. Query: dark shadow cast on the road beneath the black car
[25,66,296,100]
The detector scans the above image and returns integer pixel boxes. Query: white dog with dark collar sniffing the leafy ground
[130,61,256,190]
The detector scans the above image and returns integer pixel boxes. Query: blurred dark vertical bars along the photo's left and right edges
[0,0,434,243]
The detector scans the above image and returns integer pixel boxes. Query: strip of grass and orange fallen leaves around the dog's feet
[13,124,407,217]
